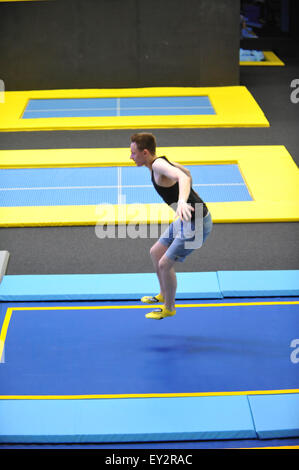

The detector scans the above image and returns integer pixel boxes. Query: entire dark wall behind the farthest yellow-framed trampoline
[0,0,239,90]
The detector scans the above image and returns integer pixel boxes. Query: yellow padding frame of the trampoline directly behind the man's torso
[0,145,299,227]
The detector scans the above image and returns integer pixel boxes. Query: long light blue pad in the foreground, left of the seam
[0,396,256,443]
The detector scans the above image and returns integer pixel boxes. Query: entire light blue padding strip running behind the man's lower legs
[0,270,299,301]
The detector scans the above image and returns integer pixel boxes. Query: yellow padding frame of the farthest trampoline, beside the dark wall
[0,86,269,132]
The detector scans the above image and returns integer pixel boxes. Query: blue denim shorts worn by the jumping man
[159,212,213,262]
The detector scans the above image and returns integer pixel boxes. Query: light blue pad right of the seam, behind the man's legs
[217,270,299,297]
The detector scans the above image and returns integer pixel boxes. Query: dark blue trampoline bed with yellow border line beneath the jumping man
[0,297,299,396]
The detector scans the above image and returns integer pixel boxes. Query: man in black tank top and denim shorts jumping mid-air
[130,133,213,320]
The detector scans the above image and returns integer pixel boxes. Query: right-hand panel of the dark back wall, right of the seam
[139,0,240,86]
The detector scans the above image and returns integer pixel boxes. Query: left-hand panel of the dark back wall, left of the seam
[0,0,137,90]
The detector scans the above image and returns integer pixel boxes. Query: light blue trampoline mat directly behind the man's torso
[0,164,252,207]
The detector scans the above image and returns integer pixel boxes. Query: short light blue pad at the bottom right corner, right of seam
[248,394,299,439]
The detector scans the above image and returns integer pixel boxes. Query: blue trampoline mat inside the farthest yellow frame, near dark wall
[22,96,216,119]
